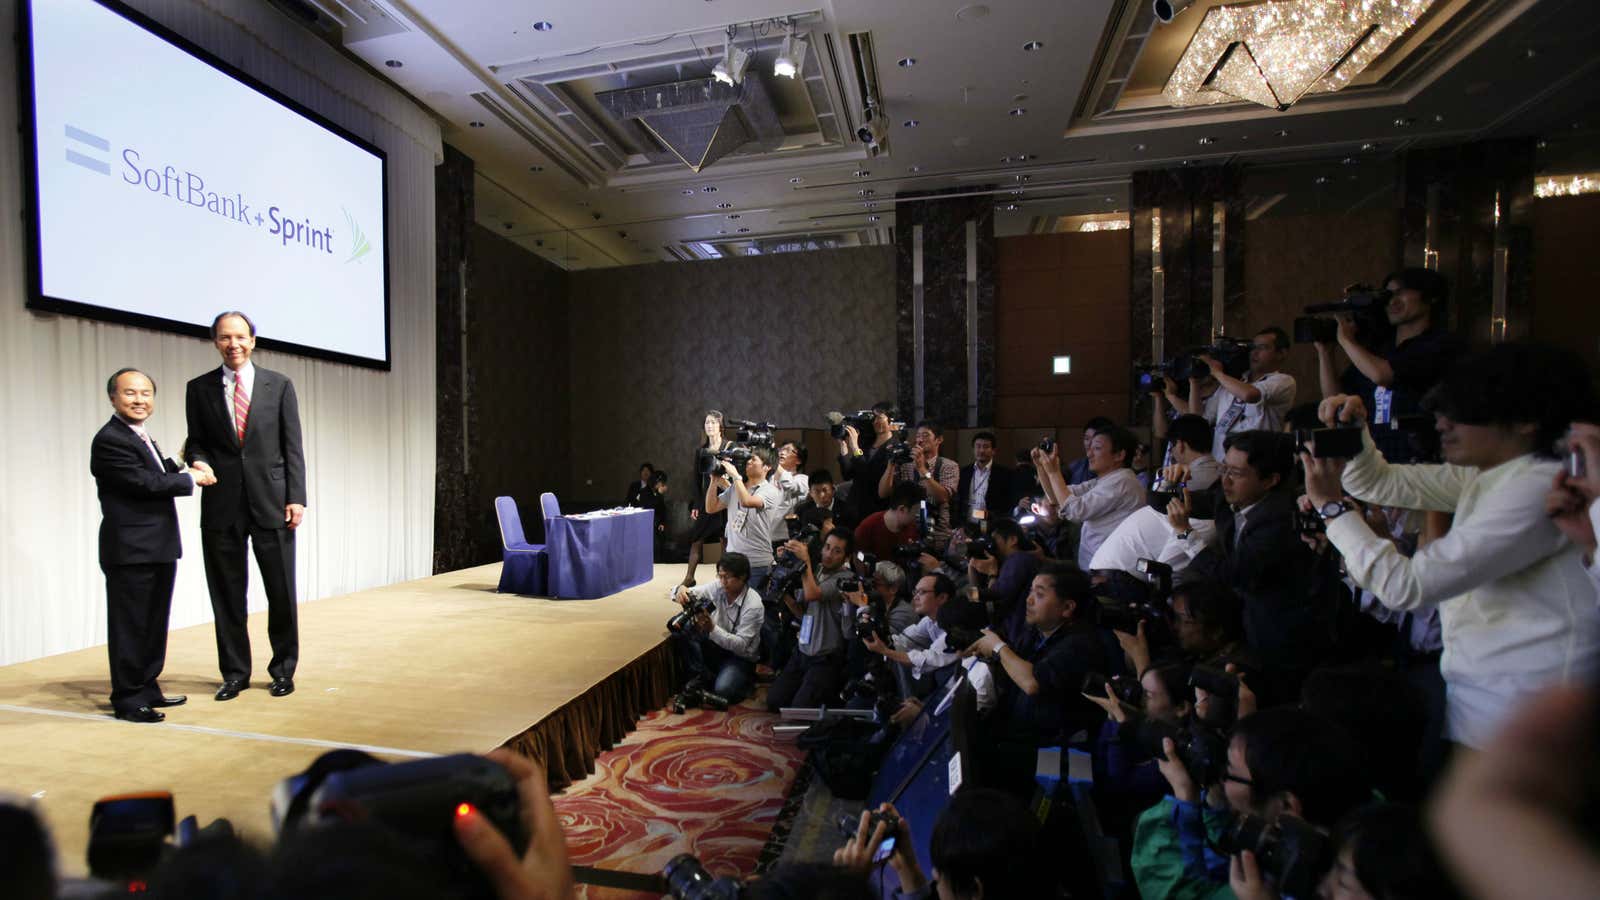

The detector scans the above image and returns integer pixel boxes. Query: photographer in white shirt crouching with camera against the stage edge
[667,552,765,705]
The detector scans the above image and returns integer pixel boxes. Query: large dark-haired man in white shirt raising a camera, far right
[1304,343,1600,748]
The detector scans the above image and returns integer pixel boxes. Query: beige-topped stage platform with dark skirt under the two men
[0,564,683,876]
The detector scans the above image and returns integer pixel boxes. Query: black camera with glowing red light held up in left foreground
[274,749,533,898]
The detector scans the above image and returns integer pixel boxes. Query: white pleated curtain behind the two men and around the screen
[0,0,442,666]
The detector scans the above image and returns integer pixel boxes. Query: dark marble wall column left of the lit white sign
[896,189,995,428]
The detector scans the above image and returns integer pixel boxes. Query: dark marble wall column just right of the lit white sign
[1128,167,1245,421]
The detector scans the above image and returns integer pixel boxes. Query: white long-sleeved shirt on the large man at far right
[1328,432,1600,746]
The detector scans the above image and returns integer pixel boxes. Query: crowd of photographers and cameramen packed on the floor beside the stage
[12,269,1600,900]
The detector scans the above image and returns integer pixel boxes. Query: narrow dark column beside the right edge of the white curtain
[434,144,482,573]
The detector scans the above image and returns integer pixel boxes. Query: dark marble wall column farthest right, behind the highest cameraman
[1402,138,1536,343]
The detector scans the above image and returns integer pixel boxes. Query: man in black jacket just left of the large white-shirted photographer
[1170,431,1339,693]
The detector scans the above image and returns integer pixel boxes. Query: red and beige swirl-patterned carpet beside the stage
[554,688,805,900]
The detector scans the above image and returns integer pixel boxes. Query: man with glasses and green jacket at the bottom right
[1133,706,1371,900]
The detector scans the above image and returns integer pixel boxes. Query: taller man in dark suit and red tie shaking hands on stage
[184,311,306,700]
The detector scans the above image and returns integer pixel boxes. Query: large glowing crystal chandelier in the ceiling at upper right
[1162,0,1435,109]
